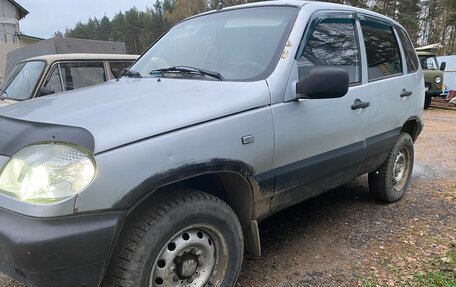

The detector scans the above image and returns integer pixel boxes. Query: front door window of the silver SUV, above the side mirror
[297,14,361,83]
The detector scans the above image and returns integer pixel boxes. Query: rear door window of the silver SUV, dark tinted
[360,17,402,81]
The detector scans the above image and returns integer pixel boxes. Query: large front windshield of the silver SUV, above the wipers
[131,7,298,81]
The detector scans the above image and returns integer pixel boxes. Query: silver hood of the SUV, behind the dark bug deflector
[0,78,270,153]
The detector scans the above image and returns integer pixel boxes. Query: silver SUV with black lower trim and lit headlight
[0,1,424,287]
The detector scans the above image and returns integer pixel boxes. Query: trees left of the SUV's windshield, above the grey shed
[54,0,259,54]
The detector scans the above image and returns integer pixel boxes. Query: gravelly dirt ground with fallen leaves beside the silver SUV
[0,107,456,287]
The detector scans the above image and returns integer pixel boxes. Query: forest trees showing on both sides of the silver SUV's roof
[54,0,456,55]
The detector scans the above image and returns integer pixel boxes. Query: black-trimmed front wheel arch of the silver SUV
[109,159,261,262]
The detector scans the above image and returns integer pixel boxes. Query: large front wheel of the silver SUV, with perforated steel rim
[103,190,244,287]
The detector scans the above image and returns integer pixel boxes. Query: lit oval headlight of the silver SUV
[0,143,96,203]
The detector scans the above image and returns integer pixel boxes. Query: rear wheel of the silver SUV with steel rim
[369,133,414,202]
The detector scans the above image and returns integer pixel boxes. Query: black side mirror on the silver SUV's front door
[296,68,349,99]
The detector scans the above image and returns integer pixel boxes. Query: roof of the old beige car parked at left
[21,53,139,63]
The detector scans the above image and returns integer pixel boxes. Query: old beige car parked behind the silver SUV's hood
[0,54,138,106]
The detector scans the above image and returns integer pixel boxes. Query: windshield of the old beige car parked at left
[0,61,44,100]
